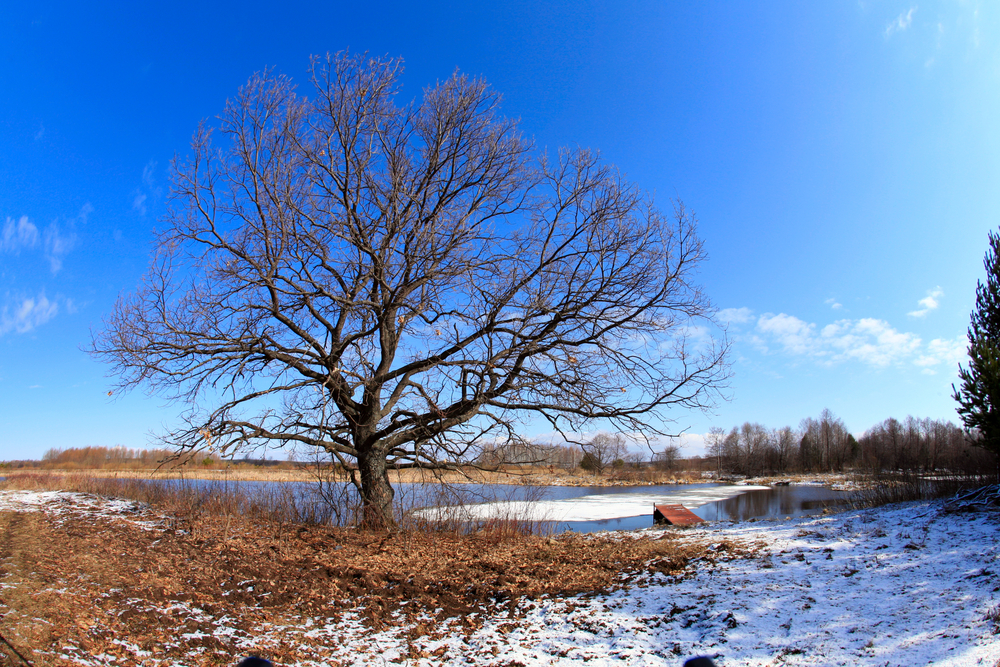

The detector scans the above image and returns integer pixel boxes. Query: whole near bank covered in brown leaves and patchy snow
[0,491,1000,667]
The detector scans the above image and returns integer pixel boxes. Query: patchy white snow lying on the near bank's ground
[0,493,1000,666]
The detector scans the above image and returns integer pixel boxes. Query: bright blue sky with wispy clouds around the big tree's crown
[0,0,1000,459]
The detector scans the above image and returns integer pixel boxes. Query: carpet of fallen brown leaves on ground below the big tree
[0,496,752,665]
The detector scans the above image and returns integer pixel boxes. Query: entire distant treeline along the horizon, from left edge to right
[11,410,998,477]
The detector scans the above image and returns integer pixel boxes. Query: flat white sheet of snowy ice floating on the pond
[414,485,771,522]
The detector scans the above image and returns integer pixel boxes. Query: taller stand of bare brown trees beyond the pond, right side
[706,410,997,477]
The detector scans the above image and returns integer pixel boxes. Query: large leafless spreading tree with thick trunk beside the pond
[93,54,728,529]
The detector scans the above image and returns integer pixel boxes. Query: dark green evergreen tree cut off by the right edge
[952,232,1000,472]
